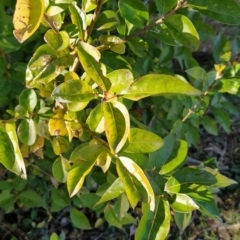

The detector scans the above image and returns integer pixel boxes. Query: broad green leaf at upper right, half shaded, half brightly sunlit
[164,14,199,51]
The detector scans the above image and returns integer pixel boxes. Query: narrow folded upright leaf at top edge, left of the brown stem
[69,1,87,40]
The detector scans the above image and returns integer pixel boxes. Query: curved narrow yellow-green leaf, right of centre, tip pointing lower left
[160,140,188,174]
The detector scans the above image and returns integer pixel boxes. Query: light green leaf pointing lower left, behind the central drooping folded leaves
[95,178,124,206]
